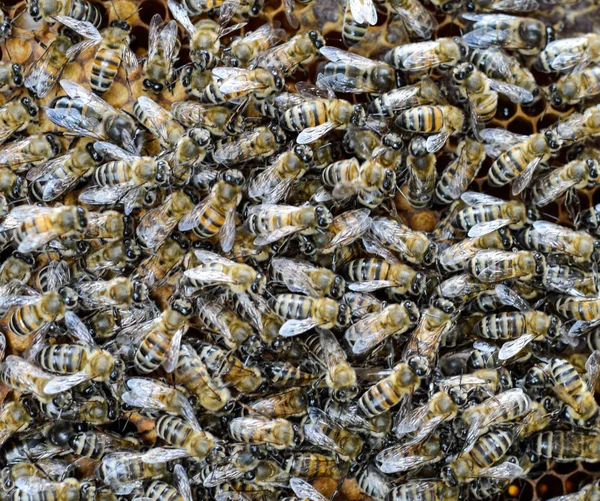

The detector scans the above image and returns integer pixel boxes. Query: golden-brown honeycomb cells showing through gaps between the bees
[0,0,600,501]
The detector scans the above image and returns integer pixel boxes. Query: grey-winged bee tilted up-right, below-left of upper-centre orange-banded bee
[213,125,287,165]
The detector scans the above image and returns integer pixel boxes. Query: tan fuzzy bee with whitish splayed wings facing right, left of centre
[184,250,266,294]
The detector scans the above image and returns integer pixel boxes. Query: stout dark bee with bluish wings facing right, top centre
[317,46,397,94]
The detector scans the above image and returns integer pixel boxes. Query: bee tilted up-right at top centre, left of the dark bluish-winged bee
[254,31,325,76]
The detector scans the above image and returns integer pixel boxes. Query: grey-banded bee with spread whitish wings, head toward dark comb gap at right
[452,191,537,237]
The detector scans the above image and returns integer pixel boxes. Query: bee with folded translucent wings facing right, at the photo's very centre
[271,258,346,299]
